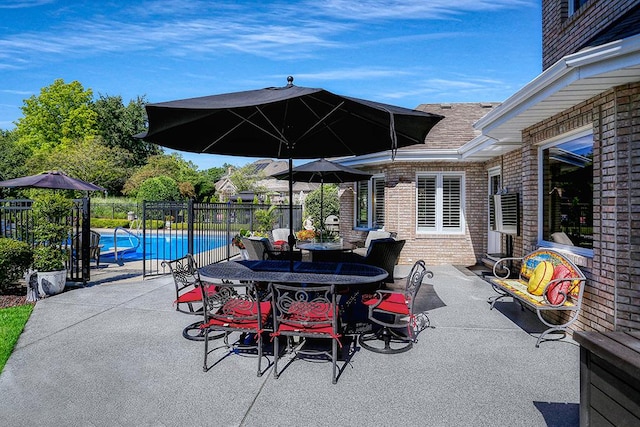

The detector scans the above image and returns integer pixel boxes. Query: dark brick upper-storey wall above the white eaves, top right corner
[542,0,640,70]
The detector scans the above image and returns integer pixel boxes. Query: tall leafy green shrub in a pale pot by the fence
[32,191,72,297]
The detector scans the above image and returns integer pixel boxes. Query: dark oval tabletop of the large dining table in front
[199,260,388,287]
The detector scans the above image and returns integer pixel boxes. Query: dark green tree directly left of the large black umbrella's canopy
[93,95,162,166]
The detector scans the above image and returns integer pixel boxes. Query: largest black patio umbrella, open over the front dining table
[138,77,443,260]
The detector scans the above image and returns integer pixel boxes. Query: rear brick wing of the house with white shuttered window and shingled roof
[339,103,499,265]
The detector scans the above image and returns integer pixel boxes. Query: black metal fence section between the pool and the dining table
[141,201,302,276]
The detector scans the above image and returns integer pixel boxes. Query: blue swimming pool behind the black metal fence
[100,233,227,262]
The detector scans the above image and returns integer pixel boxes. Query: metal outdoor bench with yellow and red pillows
[488,249,586,347]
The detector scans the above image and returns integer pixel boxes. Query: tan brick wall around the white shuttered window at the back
[339,160,488,266]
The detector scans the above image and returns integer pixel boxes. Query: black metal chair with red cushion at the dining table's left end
[161,254,222,341]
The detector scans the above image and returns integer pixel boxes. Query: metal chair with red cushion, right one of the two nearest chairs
[271,283,342,384]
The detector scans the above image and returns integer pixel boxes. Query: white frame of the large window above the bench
[537,125,593,258]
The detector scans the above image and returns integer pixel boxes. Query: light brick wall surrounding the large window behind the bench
[515,82,640,331]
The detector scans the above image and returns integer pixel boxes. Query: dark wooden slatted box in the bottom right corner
[573,332,640,426]
